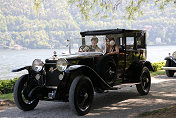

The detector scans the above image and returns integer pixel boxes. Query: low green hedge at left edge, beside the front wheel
[0,78,17,94]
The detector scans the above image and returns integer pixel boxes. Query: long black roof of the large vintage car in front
[80,28,145,37]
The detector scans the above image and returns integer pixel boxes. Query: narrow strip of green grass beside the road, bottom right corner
[139,107,170,117]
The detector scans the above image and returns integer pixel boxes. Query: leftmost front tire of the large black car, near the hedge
[13,75,39,111]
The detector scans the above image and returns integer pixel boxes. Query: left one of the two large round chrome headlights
[32,59,44,72]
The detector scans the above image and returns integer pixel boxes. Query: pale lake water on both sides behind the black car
[0,45,176,80]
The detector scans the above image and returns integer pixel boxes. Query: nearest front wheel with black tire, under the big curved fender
[69,76,94,116]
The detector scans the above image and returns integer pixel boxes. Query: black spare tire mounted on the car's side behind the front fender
[96,55,116,86]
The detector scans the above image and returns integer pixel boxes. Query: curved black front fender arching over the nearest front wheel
[56,65,112,101]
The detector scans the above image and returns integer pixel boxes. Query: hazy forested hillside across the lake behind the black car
[0,0,176,49]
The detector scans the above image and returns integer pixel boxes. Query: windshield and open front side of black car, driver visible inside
[67,35,121,53]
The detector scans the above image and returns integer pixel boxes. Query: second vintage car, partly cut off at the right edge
[162,51,176,77]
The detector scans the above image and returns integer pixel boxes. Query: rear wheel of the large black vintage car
[136,67,151,95]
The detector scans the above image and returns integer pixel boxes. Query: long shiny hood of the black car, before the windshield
[49,52,104,60]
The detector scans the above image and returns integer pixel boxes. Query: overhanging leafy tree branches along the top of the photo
[68,0,176,20]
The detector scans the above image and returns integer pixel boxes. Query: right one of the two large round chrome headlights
[56,58,68,71]
